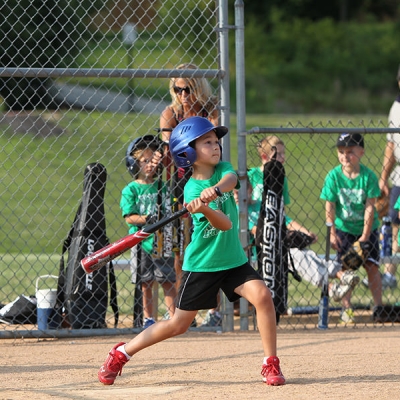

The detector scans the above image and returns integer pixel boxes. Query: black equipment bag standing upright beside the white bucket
[56,163,119,329]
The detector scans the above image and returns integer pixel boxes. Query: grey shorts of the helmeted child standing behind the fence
[130,247,176,284]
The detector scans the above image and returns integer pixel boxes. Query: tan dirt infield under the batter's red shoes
[0,326,400,400]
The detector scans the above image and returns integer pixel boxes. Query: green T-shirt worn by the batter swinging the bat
[182,161,247,272]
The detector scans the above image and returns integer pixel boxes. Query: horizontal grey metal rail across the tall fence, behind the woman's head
[0,67,225,79]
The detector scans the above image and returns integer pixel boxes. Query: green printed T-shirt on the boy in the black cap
[320,164,381,235]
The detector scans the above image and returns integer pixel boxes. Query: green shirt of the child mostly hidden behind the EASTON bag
[247,167,293,230]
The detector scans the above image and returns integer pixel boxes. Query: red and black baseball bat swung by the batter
[81,208,188,274]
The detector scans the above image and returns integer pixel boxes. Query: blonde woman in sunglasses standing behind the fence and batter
[160,63,222,326]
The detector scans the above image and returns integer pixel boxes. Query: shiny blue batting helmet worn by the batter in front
[169,117,228,168]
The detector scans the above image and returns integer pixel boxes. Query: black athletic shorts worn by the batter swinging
[176,263,262,311]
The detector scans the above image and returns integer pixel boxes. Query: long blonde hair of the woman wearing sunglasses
[169,63,218,115]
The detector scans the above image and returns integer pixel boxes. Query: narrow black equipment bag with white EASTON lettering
[256,148,288,322]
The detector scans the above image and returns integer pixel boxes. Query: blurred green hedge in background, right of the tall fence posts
[245,13,399,113]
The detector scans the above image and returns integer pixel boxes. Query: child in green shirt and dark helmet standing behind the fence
[120,135,176,329]
